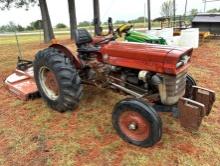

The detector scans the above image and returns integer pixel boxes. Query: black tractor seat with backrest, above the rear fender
[74,29,100,54]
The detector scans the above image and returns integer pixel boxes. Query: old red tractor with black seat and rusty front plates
[34,29,215,147]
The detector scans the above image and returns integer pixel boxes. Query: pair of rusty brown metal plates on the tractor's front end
[178,86,215,130]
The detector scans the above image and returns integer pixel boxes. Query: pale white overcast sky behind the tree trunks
[0,0,220,26]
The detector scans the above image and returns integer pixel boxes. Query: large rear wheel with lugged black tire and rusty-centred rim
[34,48,82,112]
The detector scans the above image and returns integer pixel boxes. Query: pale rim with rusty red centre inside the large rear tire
[39,67,59,100]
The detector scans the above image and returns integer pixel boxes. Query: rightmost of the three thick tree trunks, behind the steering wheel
[93,0,101,35]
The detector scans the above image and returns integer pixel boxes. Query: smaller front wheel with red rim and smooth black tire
[112,99,162,147]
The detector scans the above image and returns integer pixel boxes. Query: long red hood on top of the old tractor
[101,42,192,75]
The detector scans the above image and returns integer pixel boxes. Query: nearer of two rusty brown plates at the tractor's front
[178,98,205,130]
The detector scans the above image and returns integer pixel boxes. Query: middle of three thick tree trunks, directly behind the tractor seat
[68,0,77,40]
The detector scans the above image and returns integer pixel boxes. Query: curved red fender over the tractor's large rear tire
[49,44,82,69]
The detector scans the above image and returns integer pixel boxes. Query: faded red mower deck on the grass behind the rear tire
[5,68,38,100]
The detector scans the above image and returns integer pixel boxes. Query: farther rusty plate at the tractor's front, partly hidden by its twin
[193,86,215,116]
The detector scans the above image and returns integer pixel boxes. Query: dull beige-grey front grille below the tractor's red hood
[159,71,186,105]
